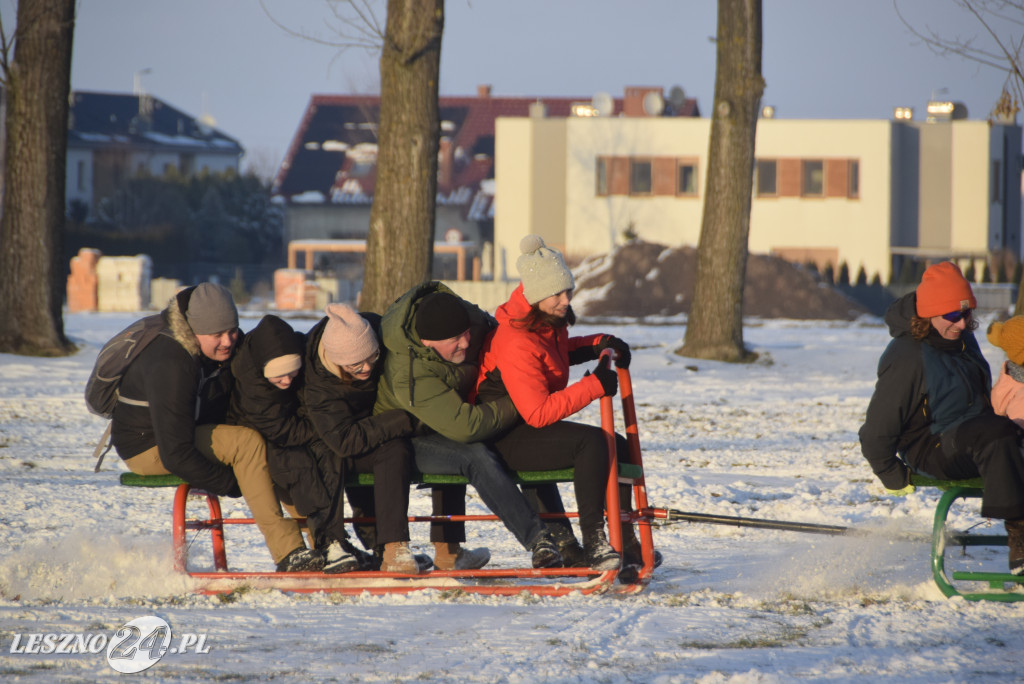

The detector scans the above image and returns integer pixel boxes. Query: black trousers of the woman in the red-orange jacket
[492,421,629,542]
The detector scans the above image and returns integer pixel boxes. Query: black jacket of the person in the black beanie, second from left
[227,315,316,446]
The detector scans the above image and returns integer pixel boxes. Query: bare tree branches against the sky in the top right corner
[893,0,1024,119]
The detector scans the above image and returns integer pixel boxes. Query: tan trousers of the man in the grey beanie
[125,425,305,563]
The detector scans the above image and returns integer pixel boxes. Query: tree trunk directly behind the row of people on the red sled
[359,0,444,312]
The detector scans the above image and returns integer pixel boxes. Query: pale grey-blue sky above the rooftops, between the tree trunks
[61,0,1005,178]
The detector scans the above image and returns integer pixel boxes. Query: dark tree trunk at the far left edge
[0,0,75,355]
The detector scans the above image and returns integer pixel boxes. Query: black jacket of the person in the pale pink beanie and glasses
[302,312,414,458]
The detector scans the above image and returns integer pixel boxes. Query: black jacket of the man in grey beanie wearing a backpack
[111,288,241,497]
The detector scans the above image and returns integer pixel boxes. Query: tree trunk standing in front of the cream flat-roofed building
[677,0,765,361]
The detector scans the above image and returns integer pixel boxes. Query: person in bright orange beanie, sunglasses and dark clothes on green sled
[860,261,1024,574]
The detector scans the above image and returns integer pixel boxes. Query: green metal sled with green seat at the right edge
[910,475,1024,601]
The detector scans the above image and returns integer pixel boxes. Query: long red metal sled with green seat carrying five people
[121,360,654,596]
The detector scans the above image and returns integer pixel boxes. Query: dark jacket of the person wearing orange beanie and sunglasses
[860,292,991,489]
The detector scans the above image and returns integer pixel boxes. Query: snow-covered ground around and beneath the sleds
[0,314,1024,683]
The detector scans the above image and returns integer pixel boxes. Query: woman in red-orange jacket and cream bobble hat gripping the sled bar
[477,236,659,569]
